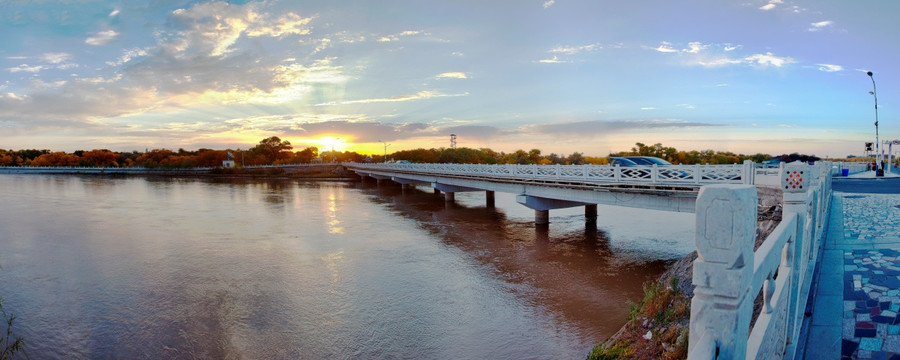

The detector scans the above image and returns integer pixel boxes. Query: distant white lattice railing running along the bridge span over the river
[344,161,756,184]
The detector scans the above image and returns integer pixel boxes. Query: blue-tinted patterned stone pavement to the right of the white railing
[804,179,900,360]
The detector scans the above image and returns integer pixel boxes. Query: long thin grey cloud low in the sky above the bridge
[534,119,722,136]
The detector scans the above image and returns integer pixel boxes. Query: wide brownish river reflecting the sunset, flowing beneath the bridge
[0,175,694,359]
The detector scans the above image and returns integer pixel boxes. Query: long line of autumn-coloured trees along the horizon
[0,136,818,169]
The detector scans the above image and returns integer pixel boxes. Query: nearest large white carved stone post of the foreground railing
[688,185,757,360]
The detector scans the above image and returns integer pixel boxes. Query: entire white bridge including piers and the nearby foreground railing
[345,162,865,360]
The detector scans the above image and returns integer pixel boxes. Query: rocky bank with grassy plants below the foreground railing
[588,187,783,360]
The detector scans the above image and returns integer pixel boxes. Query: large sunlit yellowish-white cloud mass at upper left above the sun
[0,2,348,129]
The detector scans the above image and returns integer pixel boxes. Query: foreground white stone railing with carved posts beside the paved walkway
[688,162,832,360]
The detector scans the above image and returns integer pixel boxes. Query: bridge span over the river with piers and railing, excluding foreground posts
[344,163,755,224]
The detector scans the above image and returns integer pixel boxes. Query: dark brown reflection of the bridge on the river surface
[361,184,672,343]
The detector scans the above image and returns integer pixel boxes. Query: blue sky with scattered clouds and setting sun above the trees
[0,0,900,157]
